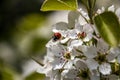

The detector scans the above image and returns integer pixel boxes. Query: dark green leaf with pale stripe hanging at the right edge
[94,12,120,46]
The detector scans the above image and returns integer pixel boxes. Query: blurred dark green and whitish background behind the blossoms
[0,0,120,80]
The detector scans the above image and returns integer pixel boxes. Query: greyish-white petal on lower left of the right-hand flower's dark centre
[86,59,99,70]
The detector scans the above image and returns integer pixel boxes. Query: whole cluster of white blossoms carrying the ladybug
[37,6,120,80]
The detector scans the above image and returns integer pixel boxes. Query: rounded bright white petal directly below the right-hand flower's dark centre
[99,63,111,75]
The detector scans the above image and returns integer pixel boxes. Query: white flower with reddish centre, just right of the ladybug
[53,11,93,41]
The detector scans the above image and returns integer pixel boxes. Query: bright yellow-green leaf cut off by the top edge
[41,0,78,11]
